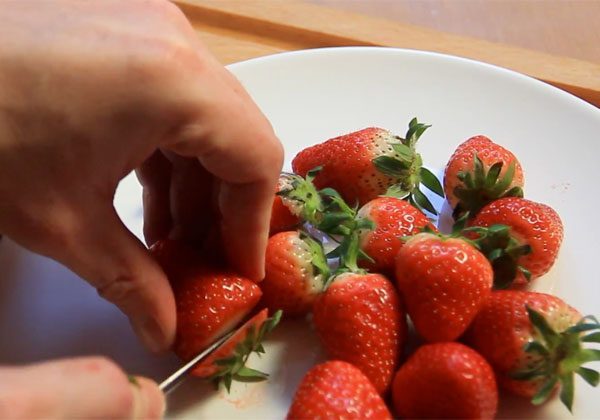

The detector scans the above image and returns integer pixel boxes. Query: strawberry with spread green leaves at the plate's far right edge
[465,290,600,410]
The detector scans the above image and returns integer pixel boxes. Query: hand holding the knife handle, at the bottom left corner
[0,357,165,419]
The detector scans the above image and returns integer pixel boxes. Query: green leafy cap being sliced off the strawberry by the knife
[208,310,282,392]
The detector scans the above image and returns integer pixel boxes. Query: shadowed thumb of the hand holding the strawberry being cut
[59,206,176,352]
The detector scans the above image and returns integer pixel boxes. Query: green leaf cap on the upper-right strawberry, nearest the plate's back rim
[453,154,523,219]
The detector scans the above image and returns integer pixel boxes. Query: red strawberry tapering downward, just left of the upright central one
[313,273,406,393]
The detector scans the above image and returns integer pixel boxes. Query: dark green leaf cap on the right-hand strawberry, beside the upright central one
[464,223,531,289]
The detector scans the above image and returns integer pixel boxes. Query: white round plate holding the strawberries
[0,48,600,419]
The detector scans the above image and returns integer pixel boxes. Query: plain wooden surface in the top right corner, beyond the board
[306,0,600,63]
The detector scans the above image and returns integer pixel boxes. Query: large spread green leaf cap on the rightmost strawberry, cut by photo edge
[510,306,600,411]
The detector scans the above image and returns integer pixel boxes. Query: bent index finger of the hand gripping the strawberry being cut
[165,69,283,280]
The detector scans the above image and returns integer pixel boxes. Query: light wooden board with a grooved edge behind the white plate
[175,0,600,107]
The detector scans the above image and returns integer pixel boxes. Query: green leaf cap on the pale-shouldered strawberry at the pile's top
[373,118,444,215]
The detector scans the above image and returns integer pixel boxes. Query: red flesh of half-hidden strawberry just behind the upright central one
[358,197,436,273]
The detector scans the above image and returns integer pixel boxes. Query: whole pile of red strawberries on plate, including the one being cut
[153,119,600,419]
